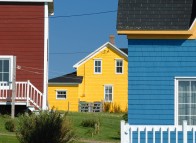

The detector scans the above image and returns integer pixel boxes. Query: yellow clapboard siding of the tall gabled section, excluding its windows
[77,48,128,110]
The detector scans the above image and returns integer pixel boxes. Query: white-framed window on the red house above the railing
[0,56,12,87]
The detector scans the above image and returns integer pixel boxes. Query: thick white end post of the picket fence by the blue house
[120,120,130,143]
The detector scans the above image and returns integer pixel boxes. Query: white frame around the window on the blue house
[174,77,196,126]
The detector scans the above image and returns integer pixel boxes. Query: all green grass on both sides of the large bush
[0,112,123,143]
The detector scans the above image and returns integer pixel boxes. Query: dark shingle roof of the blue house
[117,0,196,30]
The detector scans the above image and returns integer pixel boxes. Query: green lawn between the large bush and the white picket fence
[68,113,122,142]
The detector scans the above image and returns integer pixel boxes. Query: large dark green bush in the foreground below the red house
[16,111,76,143]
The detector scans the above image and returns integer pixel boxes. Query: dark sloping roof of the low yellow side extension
[48,72,83,84]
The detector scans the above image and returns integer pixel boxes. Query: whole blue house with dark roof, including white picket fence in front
[117,0,196,143]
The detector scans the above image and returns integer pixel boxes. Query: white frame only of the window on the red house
[0,55,13,89]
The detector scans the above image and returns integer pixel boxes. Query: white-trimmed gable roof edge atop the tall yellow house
[73,42,128,68]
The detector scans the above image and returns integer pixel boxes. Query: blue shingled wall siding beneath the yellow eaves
[128,40,196,125]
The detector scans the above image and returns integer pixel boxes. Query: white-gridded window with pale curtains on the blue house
[176,79,196,125]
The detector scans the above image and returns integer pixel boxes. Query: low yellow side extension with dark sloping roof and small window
[48,72,82,111]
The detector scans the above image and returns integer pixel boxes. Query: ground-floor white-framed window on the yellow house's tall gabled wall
[104,85,113,102]
